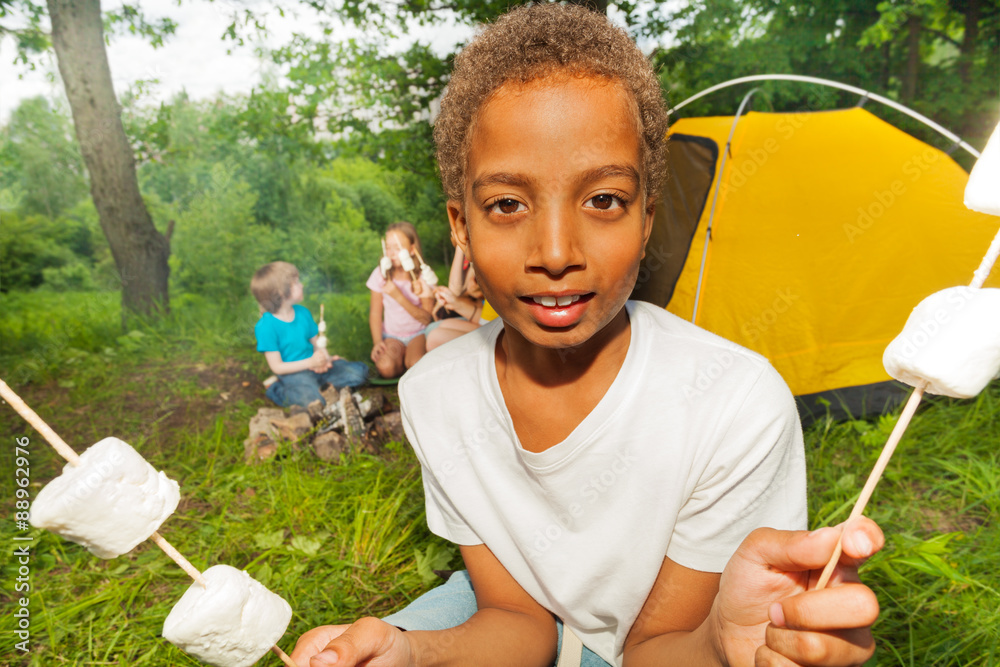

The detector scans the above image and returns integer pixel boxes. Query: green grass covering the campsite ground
[0,293,1000,666]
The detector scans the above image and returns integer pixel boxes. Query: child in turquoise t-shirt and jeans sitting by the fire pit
[250,262,368,408]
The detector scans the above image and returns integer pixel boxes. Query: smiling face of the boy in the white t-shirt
[448,74,653,348]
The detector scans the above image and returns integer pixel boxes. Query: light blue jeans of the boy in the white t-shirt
[382,570,611,667]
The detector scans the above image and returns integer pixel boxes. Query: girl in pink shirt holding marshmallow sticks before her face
[365,222,434,378]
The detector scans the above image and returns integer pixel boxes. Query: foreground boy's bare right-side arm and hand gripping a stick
[624,518,884,667]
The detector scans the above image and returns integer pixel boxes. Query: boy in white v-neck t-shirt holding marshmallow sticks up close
[292,3,882,667]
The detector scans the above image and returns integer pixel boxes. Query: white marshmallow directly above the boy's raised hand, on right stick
[882,287,1000,398]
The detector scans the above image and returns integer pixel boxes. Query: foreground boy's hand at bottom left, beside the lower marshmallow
[291,618,412,667]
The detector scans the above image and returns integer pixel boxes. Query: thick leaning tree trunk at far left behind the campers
[47,0,170,324]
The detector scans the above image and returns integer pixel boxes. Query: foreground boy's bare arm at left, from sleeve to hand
[292,545,557,667]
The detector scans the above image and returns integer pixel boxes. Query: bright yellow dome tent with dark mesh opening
[635,108,1000,408]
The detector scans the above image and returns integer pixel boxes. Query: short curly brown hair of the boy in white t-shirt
[434,3,667,203]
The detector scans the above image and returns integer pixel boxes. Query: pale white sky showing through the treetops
[0,0,470,124]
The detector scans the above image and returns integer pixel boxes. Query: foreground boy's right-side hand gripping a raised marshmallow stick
[712,517,884,665]
